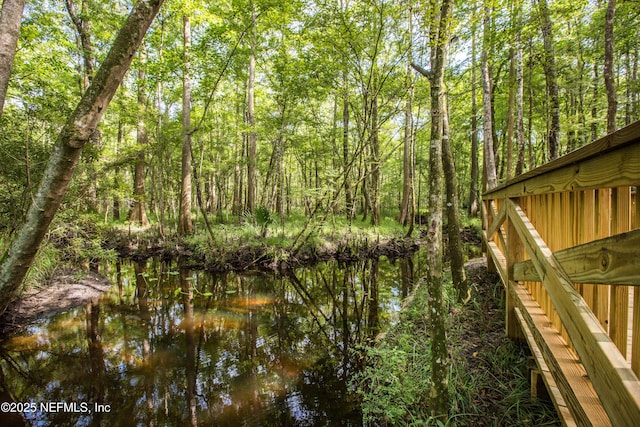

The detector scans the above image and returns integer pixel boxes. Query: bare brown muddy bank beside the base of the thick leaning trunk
[0,269,112,339]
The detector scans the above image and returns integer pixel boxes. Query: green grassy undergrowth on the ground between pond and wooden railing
[352,269,559,426]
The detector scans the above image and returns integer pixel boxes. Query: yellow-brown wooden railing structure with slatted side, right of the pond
[483,122,640,427]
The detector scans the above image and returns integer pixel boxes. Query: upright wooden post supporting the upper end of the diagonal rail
[504,199,525,341]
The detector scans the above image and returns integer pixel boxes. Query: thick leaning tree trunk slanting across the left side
[0,0,163,312]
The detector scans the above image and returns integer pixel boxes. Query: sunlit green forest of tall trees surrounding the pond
[0,0,640,424]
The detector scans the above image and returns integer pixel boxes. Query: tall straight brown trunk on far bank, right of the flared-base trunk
[178,15,193,236]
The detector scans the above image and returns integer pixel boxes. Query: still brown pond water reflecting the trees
[0,258,416,426]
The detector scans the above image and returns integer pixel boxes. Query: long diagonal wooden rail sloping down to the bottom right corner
[507,201,640,427]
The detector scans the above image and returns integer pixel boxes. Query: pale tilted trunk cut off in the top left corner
[0,0,24,118]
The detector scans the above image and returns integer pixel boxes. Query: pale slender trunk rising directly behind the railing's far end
[480,7,498,189]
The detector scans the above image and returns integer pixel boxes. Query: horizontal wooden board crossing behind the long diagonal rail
[513,229,640,286]
